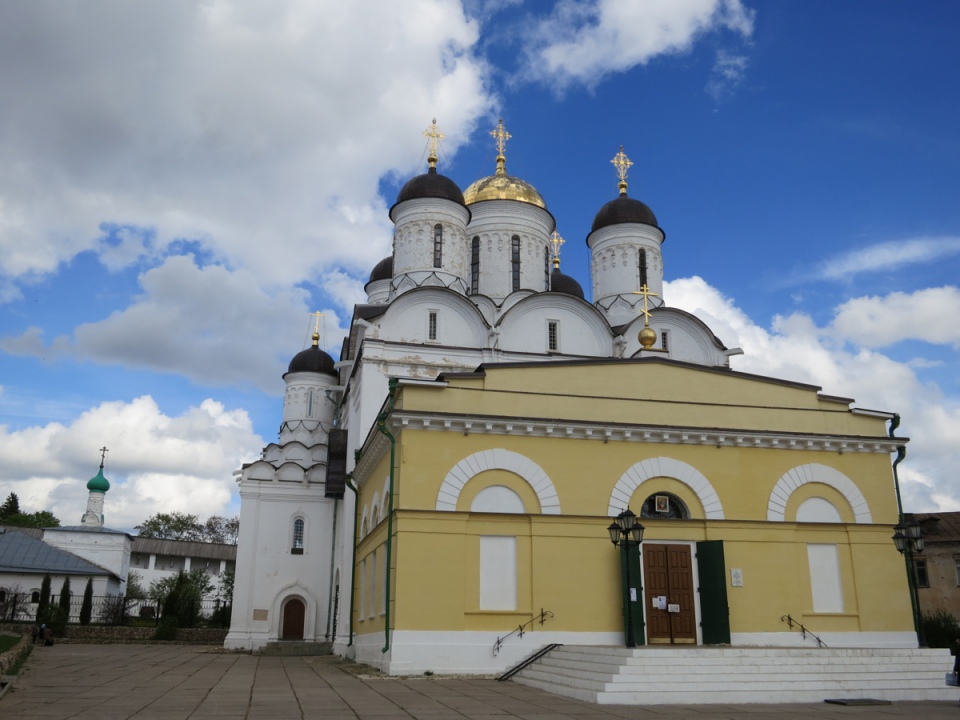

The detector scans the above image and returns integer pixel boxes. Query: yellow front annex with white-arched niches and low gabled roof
[353,353,916,673]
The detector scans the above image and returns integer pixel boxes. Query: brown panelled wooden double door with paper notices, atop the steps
[643,545,697,644]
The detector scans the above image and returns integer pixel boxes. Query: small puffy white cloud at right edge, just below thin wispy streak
[832,286,960,348]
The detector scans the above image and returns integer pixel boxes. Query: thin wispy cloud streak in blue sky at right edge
[813,237,960,280]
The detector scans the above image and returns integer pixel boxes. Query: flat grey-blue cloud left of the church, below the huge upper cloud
[0,255,346,394]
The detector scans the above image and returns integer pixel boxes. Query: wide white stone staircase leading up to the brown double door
[513,645,960,705]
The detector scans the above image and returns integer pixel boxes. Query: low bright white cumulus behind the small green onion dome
[0,396,263,529]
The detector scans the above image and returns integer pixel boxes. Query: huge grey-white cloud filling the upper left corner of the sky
[0,0,493,292]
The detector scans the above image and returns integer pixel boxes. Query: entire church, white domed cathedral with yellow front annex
[226,123,916,674]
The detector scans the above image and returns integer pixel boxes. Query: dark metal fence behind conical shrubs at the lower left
[0,593,227,625]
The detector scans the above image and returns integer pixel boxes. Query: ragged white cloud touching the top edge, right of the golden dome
[527,0,754,89]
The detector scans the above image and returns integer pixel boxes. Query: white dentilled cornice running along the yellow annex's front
[384,411,909,459]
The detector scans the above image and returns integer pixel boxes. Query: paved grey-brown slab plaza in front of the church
[0,645,960,720]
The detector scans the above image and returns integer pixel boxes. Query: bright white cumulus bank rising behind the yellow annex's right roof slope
[664,277,960,512]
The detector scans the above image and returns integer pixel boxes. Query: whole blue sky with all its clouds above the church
[0,0,960,528]
